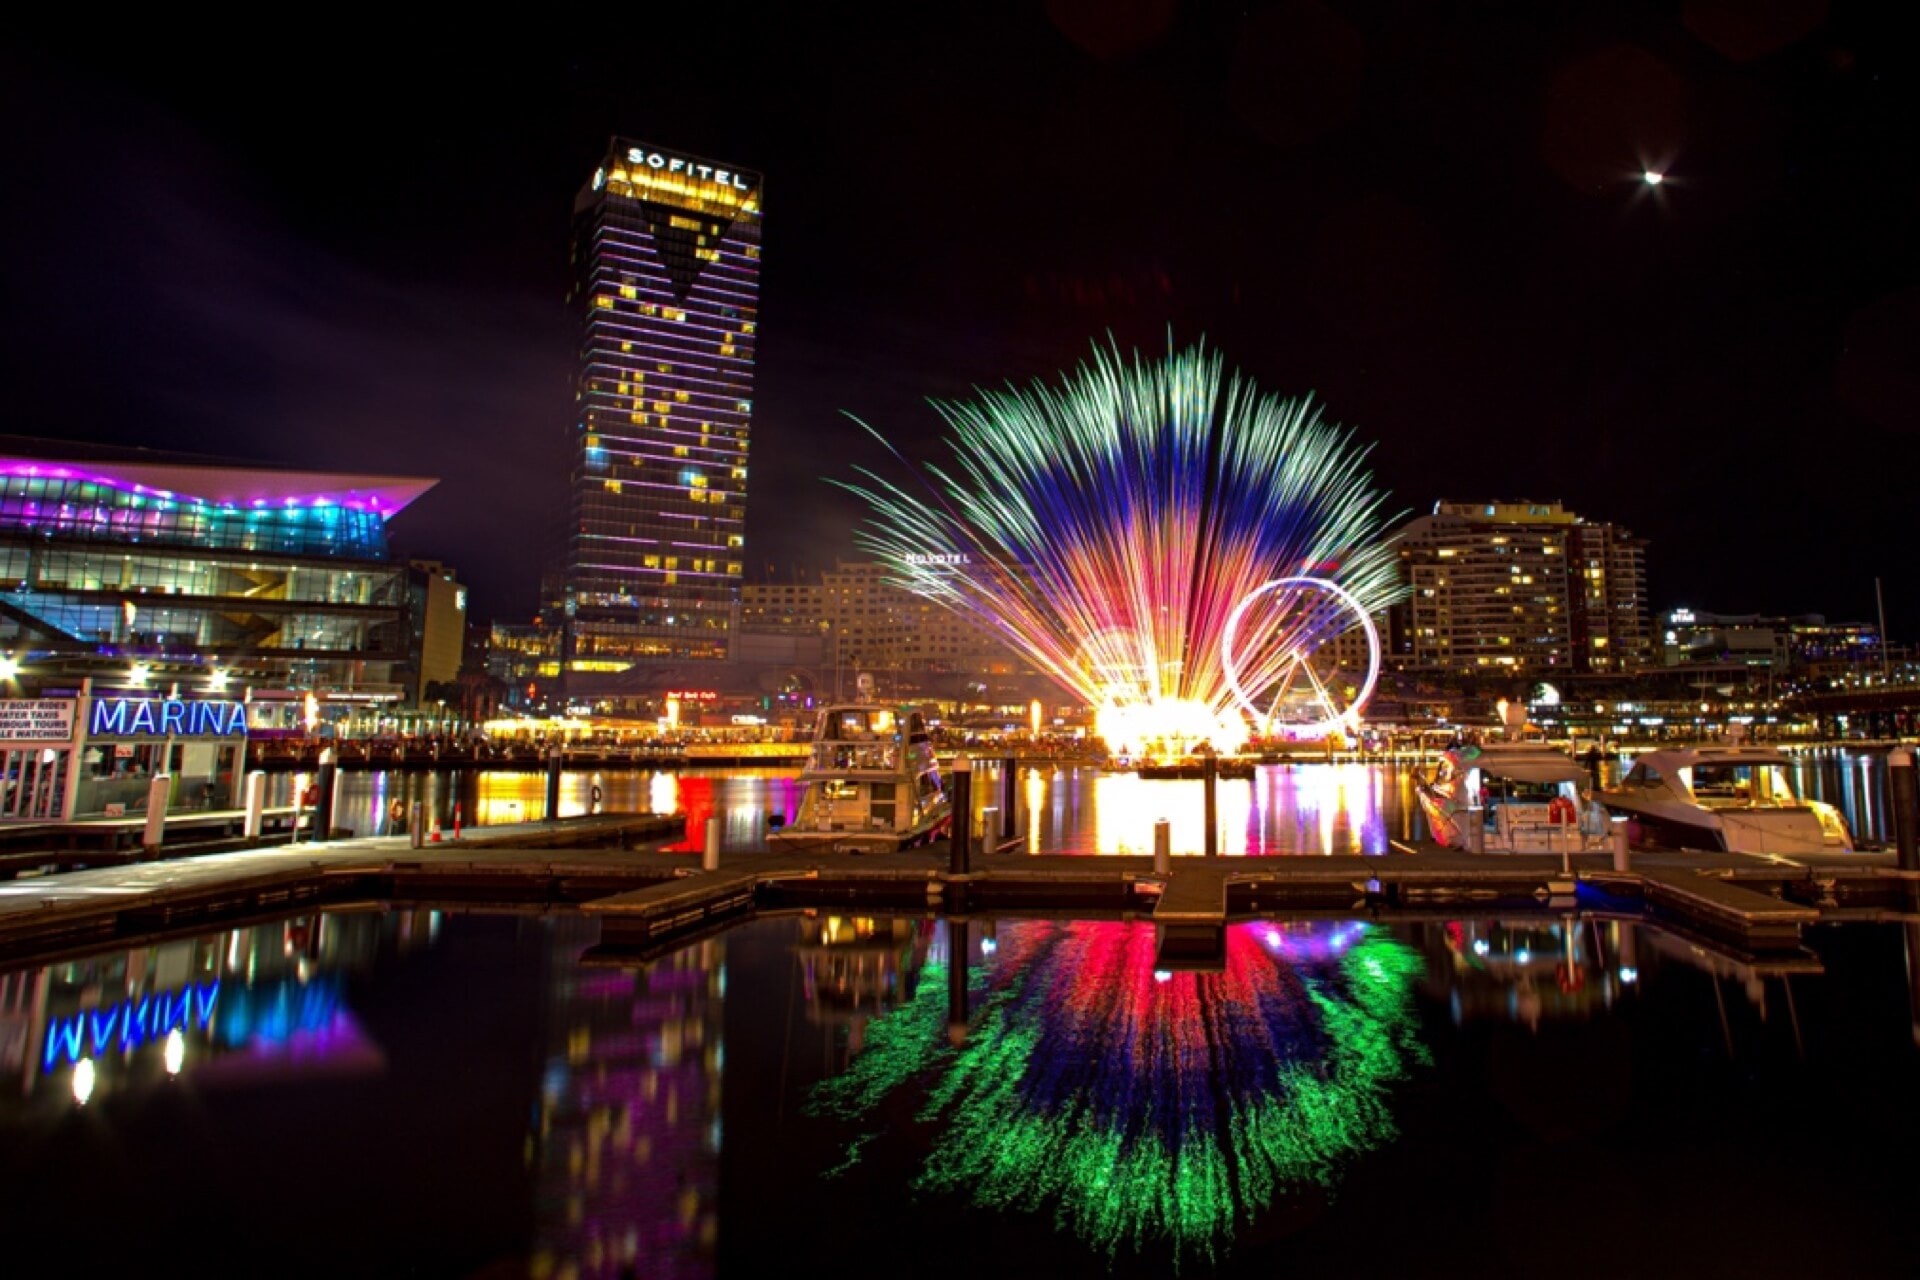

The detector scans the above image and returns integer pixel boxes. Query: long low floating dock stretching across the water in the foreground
[0,814,1912,967]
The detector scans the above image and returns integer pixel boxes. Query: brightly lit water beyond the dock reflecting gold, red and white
[280,752,1891,854]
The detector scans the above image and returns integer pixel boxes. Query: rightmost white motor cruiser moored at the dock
[1597,735,1853,854]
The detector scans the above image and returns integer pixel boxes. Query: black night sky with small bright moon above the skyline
[0,0,1920,641]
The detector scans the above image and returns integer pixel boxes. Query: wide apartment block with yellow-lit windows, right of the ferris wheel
[1394,501,1651,676]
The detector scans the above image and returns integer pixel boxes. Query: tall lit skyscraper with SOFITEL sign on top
[559,138,760,697]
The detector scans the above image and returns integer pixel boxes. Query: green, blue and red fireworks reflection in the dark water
[810,921,1425,1265]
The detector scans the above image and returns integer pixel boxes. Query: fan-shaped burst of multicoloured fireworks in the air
[843,345,1398,754]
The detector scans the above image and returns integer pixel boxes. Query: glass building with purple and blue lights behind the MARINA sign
[0,439,434,697]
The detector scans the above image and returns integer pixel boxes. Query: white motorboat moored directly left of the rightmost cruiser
[1413,741,1605,854]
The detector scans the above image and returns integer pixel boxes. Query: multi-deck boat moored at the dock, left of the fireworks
[766,676,952,854]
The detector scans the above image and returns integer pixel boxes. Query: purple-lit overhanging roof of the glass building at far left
[0,453,440,518]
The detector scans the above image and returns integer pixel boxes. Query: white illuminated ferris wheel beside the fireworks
[1221,576,1380,737]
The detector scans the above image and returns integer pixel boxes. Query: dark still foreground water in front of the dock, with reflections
[0,910,1920,1278]
